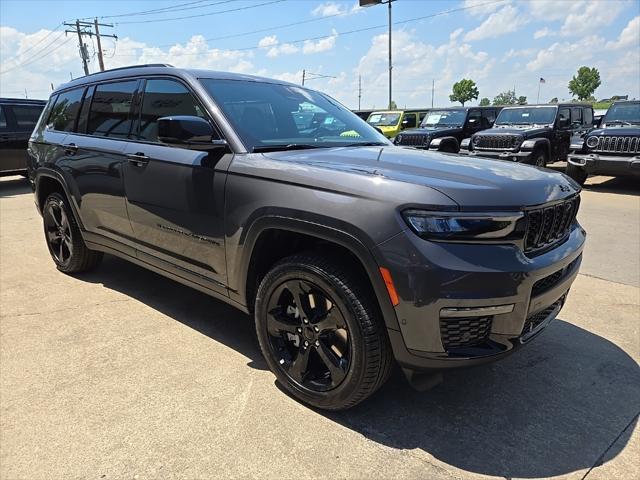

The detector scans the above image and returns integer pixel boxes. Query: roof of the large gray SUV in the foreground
[55,63,306,92]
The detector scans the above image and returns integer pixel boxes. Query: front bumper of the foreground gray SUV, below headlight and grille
[376,224,586,370]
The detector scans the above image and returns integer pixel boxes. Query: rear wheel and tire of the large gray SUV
[42,192,102,273]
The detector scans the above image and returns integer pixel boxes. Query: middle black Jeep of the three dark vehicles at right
[461,103,593,167]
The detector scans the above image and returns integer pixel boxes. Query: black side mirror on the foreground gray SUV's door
[158,115,226,149]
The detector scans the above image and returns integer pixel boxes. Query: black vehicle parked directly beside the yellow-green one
[393,107,502,153]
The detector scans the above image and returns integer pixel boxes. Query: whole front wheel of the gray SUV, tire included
[255,253,392,410]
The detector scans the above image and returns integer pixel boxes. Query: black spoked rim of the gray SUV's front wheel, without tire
[267,280,351,391]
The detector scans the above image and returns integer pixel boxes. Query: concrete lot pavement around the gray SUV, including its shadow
[0,173,640,479]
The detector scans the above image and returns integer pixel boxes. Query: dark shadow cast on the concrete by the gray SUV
[78,256,640,478]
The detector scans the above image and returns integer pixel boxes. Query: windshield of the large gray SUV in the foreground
[201,79,389,151]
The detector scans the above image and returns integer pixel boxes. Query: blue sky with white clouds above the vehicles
[0,0,640,108]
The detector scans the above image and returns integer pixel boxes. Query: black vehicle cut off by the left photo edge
[0,98,47,176]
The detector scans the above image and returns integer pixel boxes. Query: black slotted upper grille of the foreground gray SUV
[524,196,580,252]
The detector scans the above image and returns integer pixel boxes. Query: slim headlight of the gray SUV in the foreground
[402,210,524,240]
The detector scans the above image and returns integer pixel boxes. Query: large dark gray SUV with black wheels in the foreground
[29,66,585,409]
